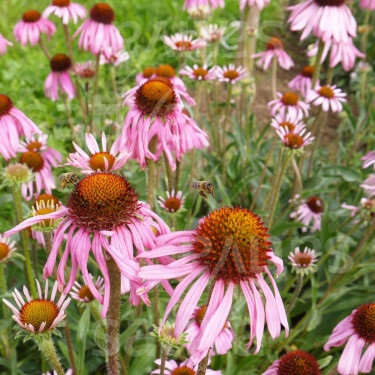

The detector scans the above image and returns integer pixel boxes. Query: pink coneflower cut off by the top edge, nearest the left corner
[43,0,87,25]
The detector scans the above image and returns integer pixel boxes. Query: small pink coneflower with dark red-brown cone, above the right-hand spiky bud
[290,197,324,232]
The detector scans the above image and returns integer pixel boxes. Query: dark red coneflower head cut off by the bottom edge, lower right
[262,350,322,375]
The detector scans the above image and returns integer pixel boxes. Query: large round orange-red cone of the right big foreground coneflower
[193,207,272,284]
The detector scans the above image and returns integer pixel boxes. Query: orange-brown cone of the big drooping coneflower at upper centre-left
[135,78,177,116]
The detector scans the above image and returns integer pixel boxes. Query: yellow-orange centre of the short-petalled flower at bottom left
[20,299,59,332]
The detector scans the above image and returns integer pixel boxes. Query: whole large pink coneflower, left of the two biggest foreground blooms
[4,173,169,318]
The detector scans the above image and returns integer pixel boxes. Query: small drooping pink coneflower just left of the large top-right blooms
[251,37,294,70]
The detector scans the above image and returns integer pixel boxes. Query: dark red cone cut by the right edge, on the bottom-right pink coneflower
[352,303,375,344]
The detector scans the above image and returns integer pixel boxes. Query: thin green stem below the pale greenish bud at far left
[13,186,38,299]
